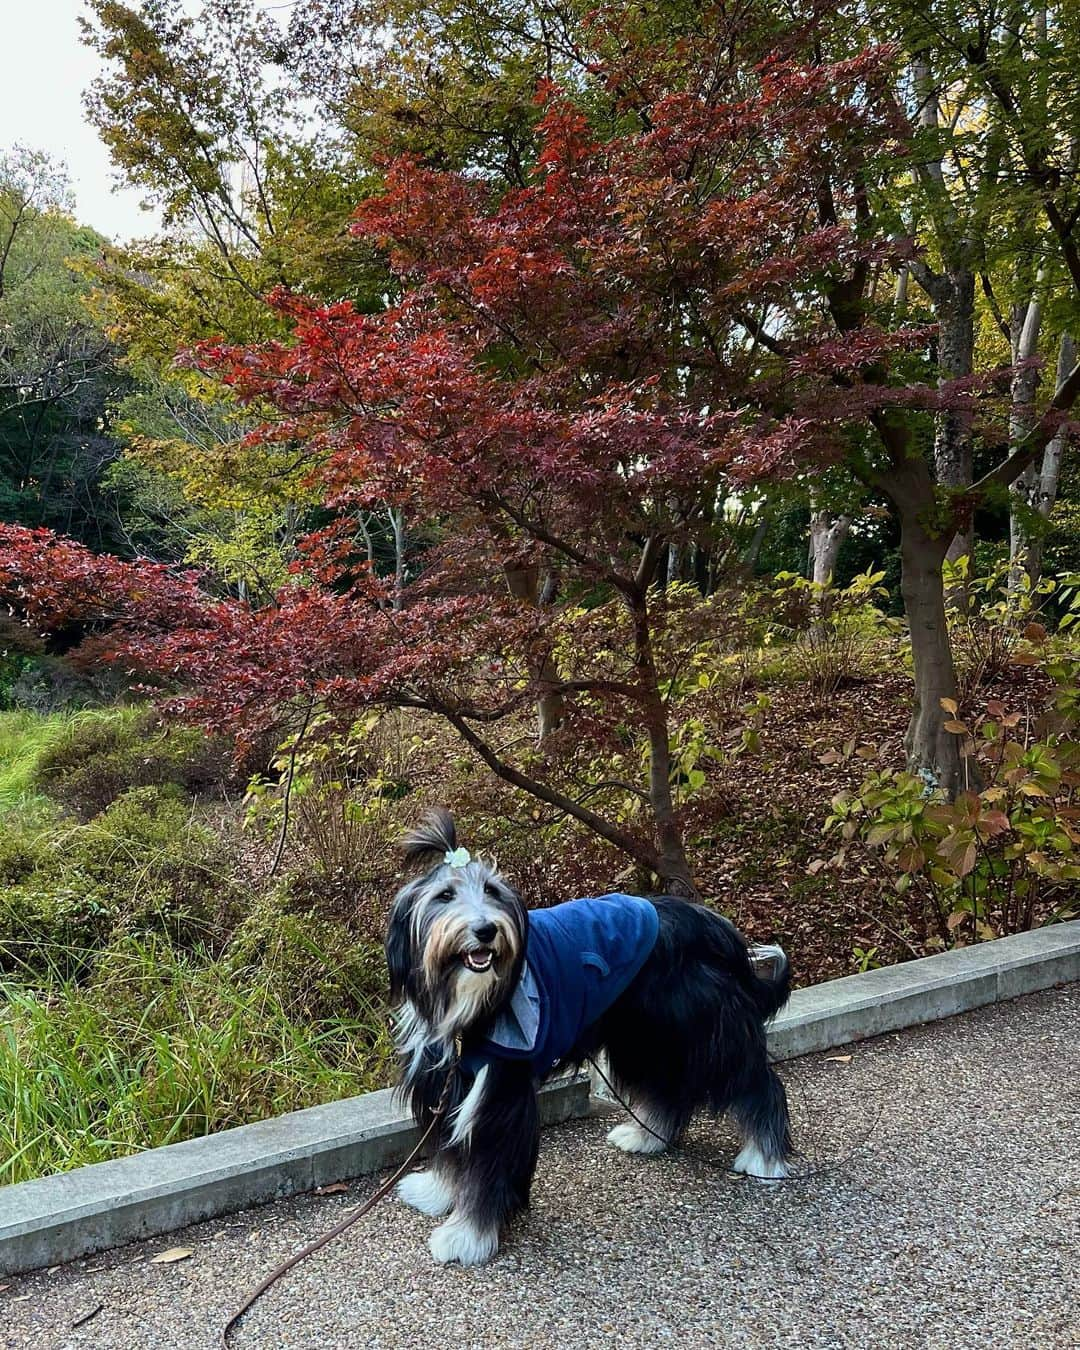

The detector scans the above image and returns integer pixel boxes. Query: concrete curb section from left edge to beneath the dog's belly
[0,1075,589,1274]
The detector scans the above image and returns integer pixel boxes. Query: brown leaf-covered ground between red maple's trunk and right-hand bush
[697,666,1046,984]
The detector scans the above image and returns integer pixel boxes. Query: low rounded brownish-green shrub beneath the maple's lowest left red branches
[35,709,238,819]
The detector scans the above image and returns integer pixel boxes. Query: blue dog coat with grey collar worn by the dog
[468,895,660,1079]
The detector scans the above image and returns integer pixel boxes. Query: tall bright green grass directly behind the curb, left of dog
[0,940,392,1184]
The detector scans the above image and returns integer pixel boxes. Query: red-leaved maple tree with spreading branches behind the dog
[0,26,940,894]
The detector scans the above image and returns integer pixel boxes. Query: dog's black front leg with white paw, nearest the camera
[428,1061,540,1265]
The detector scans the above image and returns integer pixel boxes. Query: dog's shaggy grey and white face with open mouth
[386,825,528,1035]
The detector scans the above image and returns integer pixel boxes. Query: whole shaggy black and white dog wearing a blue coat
[386,810,791,1265]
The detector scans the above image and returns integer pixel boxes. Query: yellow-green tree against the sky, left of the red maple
[84,0,386,580]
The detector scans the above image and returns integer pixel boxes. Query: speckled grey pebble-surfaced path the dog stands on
[0,986,1080,1350]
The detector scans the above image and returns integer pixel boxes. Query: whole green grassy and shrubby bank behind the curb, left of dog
[0,707,392,1185]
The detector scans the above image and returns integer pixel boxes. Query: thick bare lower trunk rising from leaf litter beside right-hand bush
[900,506,975,798]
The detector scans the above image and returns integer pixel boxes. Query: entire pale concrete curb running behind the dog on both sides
[0,921,1080,1274]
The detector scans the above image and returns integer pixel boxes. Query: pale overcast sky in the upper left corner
[0,0,291,239]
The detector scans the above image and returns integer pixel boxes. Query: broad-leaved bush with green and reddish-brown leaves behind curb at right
[825,656,1080,946]
